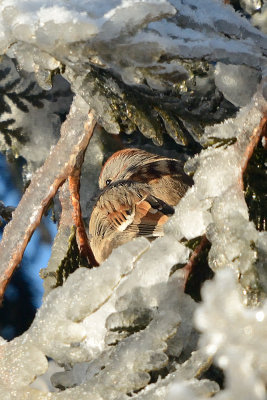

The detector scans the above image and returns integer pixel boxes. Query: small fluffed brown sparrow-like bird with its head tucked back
[89,148,193,264]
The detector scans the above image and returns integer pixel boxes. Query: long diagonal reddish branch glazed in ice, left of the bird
[0,101,95,301]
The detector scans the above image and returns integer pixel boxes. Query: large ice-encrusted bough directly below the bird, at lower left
[1,237,202,398]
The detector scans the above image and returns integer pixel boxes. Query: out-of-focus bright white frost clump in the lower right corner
[195,270,267,399]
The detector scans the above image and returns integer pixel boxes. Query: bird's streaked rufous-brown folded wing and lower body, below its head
[89,181,174,263]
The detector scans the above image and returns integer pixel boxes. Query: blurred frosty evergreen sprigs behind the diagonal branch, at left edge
[0,56,73,174]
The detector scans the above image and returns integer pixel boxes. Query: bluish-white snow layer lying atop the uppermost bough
[0,0,266,72]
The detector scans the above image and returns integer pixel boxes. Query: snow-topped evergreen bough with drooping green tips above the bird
[0,0,267,144]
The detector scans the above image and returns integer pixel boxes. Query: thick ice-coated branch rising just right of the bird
[166,81,266,302]
